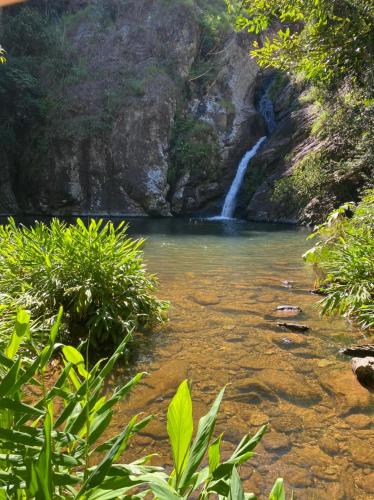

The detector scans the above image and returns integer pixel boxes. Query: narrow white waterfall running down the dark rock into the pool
[214,91,276,219]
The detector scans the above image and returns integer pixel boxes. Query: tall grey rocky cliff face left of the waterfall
[0,0,263,215]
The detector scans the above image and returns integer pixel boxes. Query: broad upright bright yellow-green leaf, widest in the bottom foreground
[167,380,193,482]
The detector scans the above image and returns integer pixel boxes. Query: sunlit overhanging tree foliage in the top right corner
[227,0,374,85]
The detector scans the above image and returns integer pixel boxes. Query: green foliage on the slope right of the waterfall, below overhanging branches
[273,87,374,216]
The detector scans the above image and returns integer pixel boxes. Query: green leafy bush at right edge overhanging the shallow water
[304,189,374,328]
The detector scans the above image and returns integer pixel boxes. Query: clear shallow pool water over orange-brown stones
[107,219,374,500]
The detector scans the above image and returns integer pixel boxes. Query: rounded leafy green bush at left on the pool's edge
[0,219,167,346]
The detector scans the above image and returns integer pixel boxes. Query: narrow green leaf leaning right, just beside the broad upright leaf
[179,389,225,489]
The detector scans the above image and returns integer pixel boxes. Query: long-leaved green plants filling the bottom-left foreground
[0,310,285,500]
